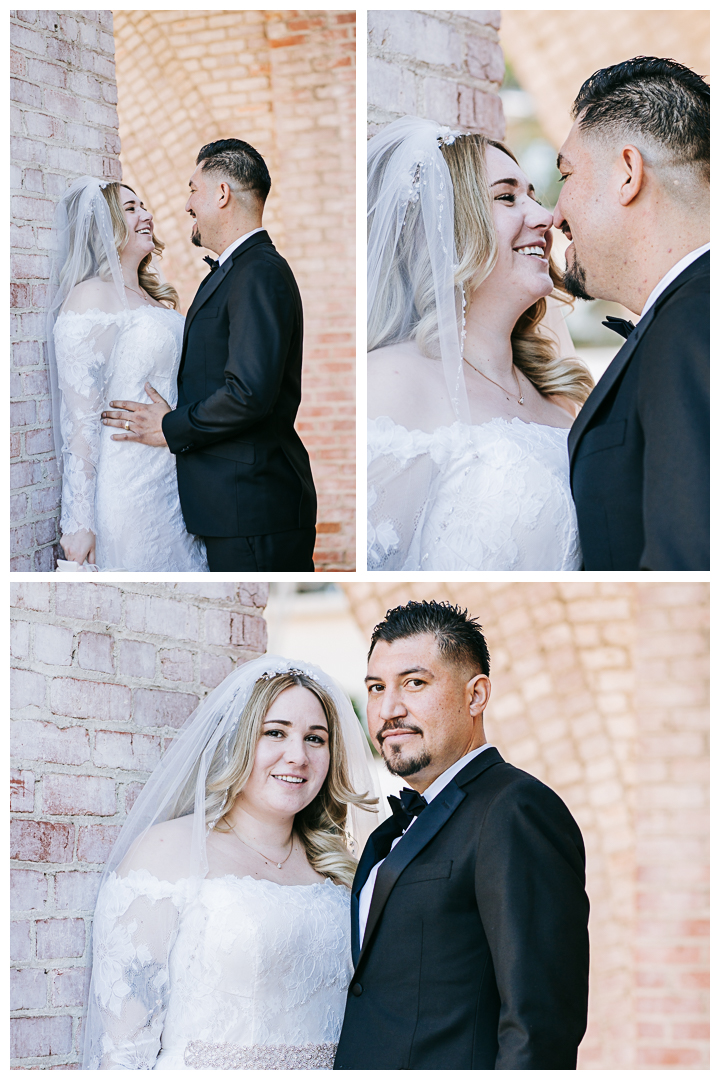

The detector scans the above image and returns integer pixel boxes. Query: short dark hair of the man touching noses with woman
[572,56,710,183]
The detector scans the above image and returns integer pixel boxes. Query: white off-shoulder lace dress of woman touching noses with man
[368,417,582,571]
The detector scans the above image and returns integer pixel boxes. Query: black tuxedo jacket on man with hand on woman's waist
[163,230,316,537]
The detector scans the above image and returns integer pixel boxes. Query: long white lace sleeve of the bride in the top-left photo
[55,311,118,534]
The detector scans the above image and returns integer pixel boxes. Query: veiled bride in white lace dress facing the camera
[83,656,378,1069]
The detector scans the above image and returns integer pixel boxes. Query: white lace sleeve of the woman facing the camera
[83,870,179,1069]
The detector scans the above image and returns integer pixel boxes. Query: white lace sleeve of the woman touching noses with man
[367,417,438,570]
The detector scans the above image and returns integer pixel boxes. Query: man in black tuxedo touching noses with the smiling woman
[553,56,710,570]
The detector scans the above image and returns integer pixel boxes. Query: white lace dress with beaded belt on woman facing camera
[86,869,352,1069]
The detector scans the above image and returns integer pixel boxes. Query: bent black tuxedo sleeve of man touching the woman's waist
[163,260,299,454]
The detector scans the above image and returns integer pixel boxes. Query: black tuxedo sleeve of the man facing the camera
[475,778,589,1069]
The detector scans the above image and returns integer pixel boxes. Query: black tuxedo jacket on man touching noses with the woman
[568,252,710,570]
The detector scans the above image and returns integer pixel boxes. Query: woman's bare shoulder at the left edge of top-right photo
[367,341,445,427]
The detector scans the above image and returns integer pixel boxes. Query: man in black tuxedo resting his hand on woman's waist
[104,138,316,571]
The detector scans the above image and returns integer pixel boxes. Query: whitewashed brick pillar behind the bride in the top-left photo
[10,11,121,570]
